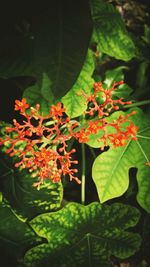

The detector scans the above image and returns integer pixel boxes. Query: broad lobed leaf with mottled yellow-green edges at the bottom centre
[25,202,140,267]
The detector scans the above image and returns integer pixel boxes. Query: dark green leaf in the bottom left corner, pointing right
[0,204,42,267]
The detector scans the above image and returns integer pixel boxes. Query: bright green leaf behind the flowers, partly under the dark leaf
[62,50,95,118]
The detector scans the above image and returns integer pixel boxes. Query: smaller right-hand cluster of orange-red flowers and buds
[75,81,138,150]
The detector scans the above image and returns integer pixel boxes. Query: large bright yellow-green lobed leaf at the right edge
[92,108,150,212]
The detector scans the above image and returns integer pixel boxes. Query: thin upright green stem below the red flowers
[81,143,85,205]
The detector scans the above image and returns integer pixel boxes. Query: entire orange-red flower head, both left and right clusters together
[0,81,138,187]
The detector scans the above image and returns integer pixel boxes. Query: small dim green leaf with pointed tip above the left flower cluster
[23,73,54,114]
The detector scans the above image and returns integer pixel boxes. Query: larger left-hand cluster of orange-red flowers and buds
[0,98,80,186]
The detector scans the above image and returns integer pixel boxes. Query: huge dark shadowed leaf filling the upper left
[0,0,92,101]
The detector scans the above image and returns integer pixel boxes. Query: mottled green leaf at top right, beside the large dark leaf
[91,0,135,61]
